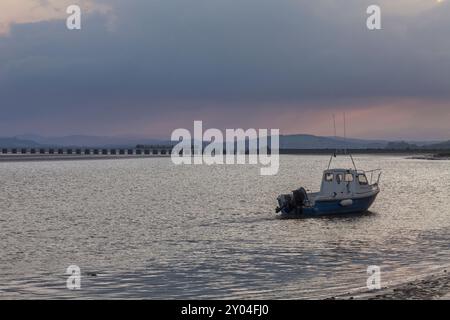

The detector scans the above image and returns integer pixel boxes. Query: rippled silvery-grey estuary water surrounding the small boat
[0,155,450,299]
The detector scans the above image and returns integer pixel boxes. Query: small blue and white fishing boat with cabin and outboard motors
[276,154,381,216]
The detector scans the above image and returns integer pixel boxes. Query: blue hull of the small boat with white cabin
[282,193,378,216]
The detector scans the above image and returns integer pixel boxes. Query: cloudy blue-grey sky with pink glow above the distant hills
[0,0,450,140]
